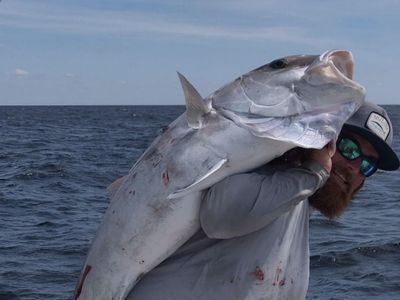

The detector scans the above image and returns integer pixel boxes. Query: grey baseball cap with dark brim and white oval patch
[343,101,400,171]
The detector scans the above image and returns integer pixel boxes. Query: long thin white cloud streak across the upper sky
[0,1,334,45]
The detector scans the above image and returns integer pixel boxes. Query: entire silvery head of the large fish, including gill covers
[209,50,365,148]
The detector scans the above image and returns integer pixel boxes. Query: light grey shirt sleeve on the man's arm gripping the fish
[200,161,329,239]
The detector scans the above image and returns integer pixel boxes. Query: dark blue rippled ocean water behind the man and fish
[0,105,400,300]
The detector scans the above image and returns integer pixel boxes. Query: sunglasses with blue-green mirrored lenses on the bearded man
[336,137,378,177]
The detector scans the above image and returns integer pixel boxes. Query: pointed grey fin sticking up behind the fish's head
[177,72,211,129]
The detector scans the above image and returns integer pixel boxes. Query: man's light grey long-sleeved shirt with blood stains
[127,161,329,300]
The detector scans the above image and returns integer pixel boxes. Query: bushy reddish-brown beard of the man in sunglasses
[308,166,363,219]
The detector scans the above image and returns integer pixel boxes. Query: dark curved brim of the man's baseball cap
[343,124,400,171]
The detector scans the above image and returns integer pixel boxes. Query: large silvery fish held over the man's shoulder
[75,50,365,300]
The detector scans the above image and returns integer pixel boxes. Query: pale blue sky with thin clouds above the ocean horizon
[0,0,400,105]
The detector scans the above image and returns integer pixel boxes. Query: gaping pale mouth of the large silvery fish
[305,50,363,89]
